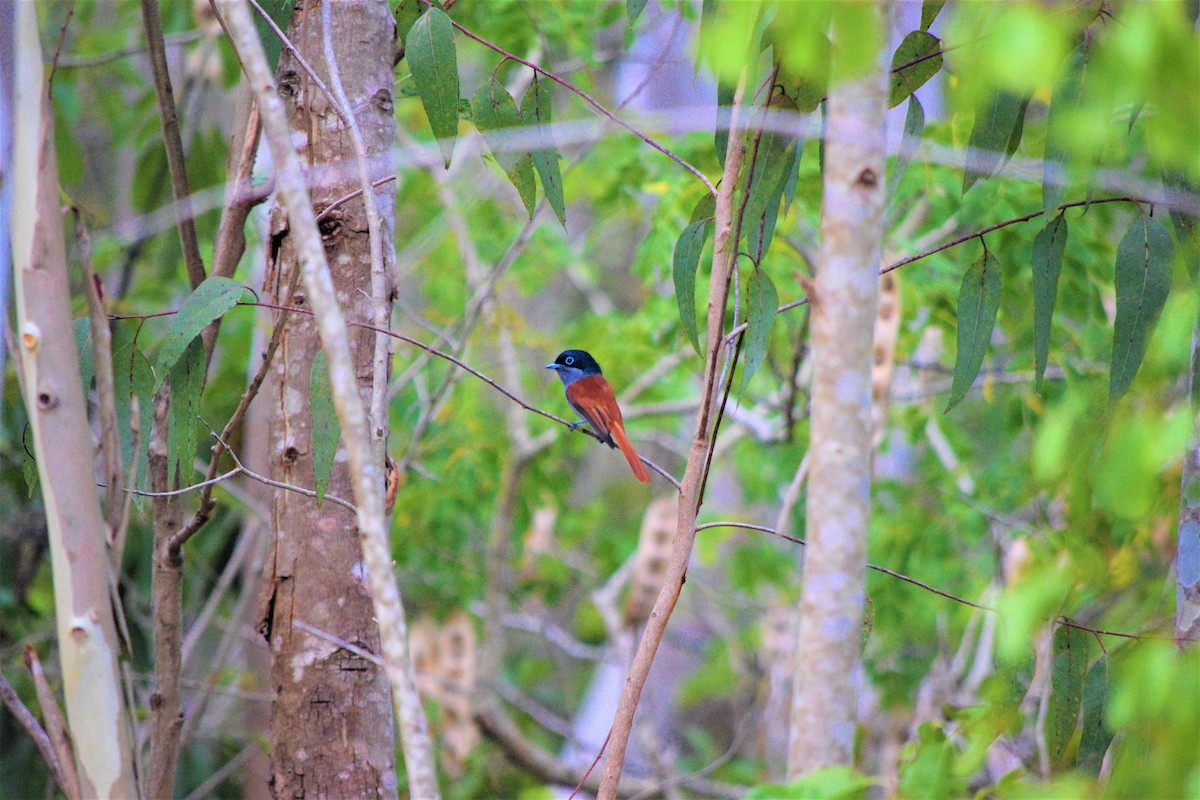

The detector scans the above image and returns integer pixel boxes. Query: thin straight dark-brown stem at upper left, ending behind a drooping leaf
[142,0,206,292]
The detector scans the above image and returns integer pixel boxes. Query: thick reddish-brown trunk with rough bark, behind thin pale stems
[264,0,396,798]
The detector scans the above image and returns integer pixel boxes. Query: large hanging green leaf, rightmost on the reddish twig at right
[1109,217,1175,402]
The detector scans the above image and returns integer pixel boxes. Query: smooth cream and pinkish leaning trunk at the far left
[6,2,137,798]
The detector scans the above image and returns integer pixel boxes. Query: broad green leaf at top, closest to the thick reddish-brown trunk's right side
[404,8,458,167]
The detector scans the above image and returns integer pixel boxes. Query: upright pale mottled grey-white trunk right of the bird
[787,5,887,778]
